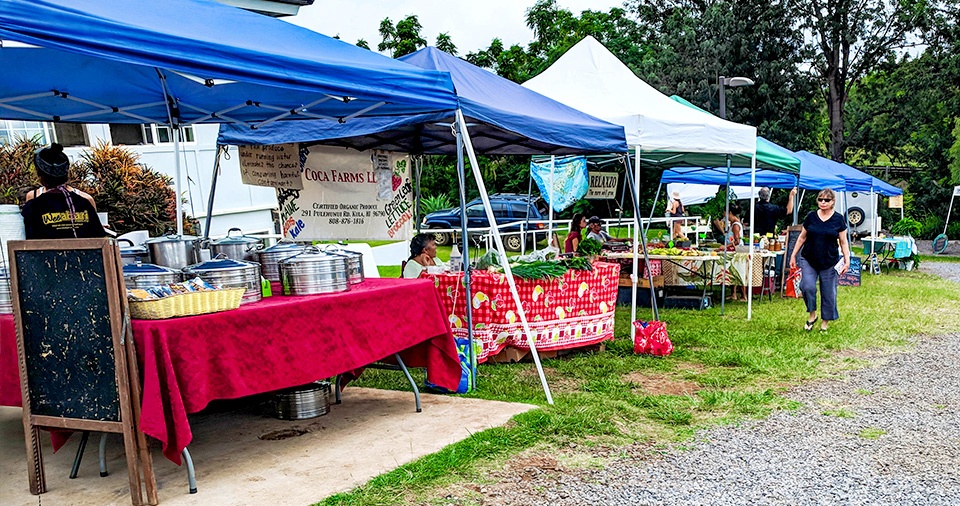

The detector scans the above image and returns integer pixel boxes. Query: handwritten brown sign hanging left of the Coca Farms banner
[239,143,303,190]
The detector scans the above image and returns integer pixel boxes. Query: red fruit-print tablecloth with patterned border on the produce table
[423,262,620,362]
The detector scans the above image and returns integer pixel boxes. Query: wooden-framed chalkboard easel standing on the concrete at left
[9,239,158,506]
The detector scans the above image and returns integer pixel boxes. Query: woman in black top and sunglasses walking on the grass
[790,189,850,332]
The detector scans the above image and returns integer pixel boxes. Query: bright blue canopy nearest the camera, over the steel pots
[0,0,457,124]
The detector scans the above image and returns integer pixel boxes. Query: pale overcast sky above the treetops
[281,0,623,56]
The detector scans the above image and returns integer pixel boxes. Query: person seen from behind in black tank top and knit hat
[20,144,106,239]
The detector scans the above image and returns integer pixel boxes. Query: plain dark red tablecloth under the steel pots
[0,279,461,464]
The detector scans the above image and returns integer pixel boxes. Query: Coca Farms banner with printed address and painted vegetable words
[277,146,413,241]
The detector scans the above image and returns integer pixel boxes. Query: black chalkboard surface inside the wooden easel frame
[16,249,120,422]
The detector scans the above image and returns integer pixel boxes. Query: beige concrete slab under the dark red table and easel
[0,387,535,506]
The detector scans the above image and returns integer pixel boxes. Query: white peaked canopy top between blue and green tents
[523,36,757,166]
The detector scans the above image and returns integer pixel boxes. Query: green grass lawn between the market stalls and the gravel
[320,258,960,505]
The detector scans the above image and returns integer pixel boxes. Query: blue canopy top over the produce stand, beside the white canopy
[219,47,627,154]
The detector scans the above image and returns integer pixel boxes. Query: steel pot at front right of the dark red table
[280,248,350,295]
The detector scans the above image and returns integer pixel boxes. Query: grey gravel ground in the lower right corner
[478,262,960,506]
